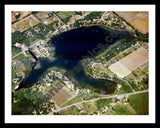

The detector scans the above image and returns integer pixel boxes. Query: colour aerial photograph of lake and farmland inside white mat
[10,10,149,116]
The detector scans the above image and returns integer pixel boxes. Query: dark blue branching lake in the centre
[16,26,131,94]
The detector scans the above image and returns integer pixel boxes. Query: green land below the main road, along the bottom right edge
[54,93,148,115]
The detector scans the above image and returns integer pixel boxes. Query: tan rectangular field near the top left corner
[12,15,40,32]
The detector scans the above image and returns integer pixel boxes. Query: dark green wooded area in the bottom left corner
[12,89,47,115]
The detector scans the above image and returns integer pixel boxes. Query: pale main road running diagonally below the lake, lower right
[54,90,148,112]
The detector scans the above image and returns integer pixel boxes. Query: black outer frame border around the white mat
[0,0,160,128]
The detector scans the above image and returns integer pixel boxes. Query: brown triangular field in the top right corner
[116,11,149,34]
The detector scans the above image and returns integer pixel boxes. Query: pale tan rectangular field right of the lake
[108,48,148,78]
